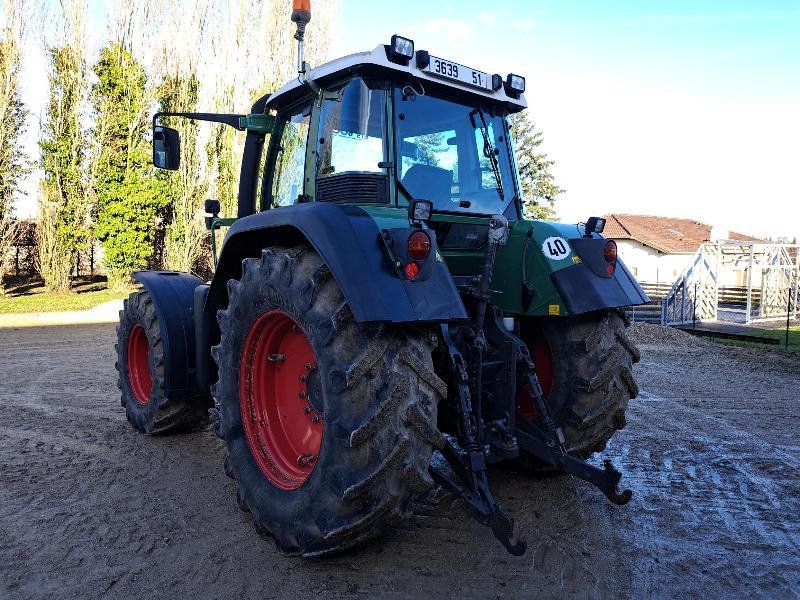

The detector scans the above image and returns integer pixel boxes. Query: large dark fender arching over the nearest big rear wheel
[205,203,467,323]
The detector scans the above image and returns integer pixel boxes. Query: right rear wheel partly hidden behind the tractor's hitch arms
[517,311,639,460]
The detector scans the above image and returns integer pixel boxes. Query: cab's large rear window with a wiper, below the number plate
[395,87,516,215]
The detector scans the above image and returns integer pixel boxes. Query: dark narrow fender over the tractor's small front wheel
[133,271,203,398]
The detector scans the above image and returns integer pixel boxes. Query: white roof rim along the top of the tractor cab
[267,45,527,113]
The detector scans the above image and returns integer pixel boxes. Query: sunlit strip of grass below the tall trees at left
[0,277,128,314]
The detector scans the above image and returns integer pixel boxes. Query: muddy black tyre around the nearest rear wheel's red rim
[212,245,446,556]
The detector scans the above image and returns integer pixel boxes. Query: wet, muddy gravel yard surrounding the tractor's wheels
[0,325,800,599]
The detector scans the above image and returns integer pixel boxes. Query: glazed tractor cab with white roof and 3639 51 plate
[258,36,525,220]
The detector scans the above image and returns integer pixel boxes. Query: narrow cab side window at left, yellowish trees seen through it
[272,104,311,207]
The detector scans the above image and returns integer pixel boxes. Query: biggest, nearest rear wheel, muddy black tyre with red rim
[212,246,446,556]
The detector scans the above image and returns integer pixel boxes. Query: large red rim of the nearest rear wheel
[239,309,324,490]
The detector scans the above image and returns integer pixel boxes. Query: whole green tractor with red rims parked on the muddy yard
[117,3,648,556]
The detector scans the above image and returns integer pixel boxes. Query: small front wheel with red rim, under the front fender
[114,291,211,435]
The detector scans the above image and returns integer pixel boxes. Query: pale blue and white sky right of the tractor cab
[17,0,800,238]
